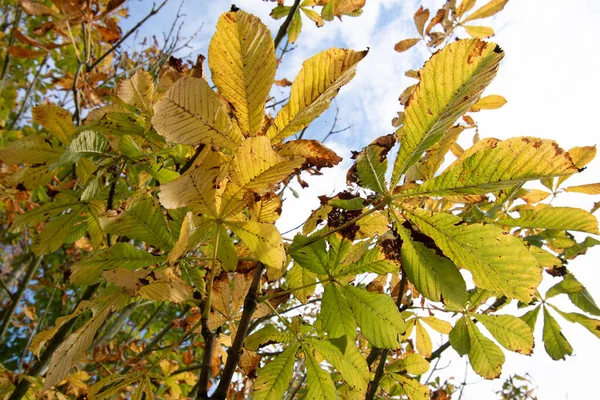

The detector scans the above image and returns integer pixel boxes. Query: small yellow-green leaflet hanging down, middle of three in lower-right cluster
[467,322,505,379]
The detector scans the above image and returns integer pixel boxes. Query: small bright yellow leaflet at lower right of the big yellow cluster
[226,221,286,269]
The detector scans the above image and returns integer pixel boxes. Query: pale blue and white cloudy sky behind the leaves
[130,0,600,400]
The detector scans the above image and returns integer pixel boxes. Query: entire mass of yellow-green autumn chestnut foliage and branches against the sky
[0,0,600,399]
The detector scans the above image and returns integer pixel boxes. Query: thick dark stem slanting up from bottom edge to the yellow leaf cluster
[211,263,265,400]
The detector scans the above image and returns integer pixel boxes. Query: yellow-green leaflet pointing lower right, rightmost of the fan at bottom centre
[307,338,369,393]
